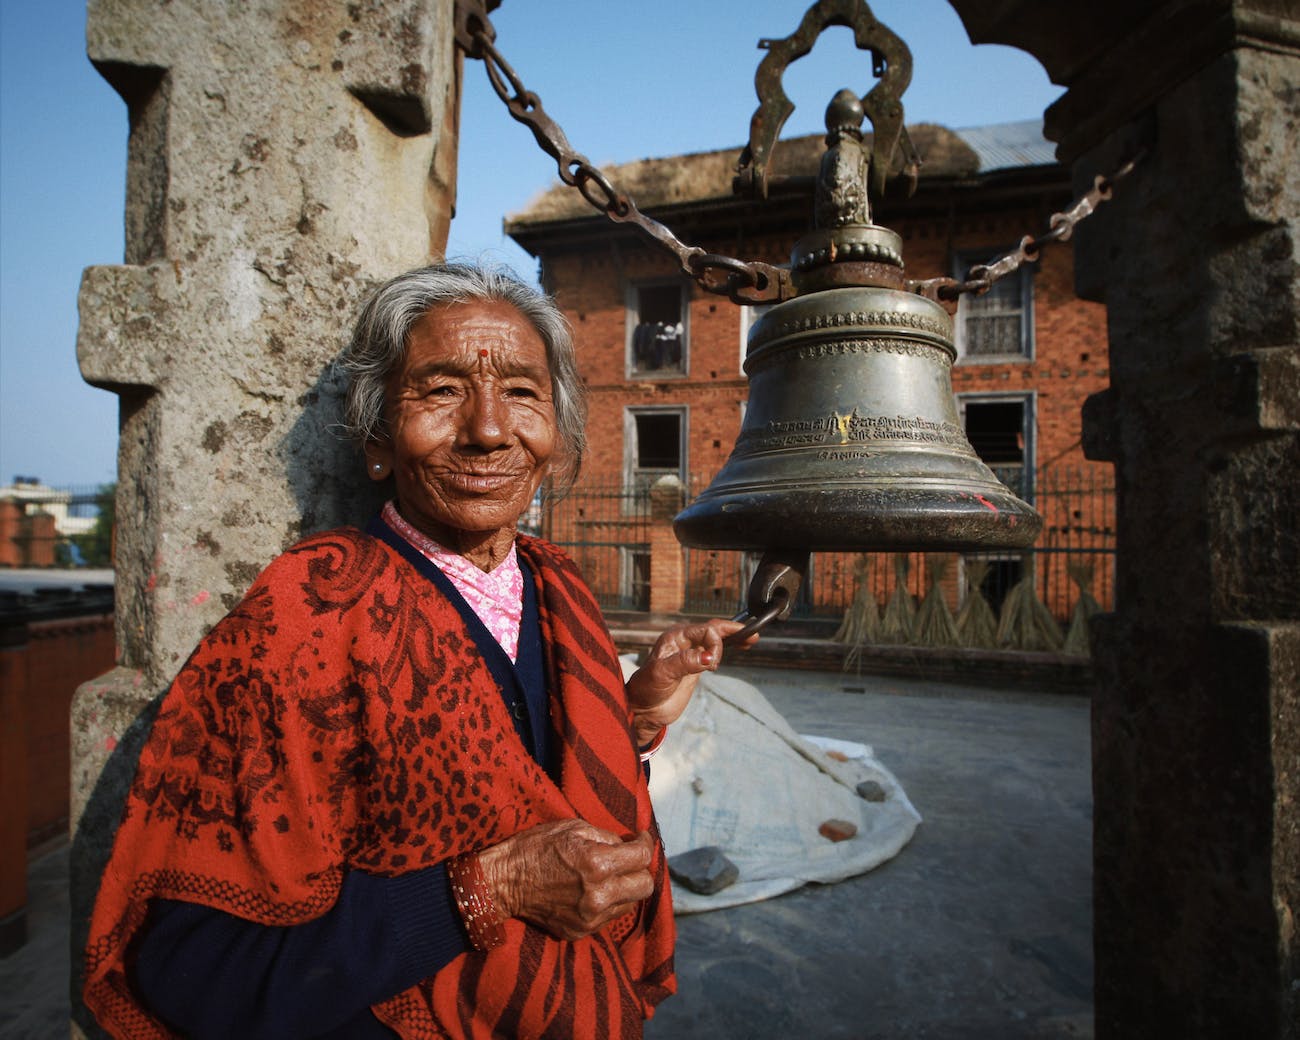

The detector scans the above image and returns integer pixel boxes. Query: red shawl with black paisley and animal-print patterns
[85,529,676,1040]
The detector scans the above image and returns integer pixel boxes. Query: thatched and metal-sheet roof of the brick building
[506,120,1057,233]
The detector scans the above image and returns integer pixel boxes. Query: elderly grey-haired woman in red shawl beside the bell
[86,265,740,1037]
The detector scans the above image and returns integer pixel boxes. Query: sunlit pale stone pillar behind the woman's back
[73,0,459,1034]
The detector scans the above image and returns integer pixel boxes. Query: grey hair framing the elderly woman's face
[341,263,586,491]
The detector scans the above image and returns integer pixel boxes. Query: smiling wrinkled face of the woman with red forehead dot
[367,302,558,549]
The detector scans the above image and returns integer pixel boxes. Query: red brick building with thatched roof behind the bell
[506,122,1109,615]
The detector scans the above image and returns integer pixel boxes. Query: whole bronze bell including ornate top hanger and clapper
[673,8,1041,627]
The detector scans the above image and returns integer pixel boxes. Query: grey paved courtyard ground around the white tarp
[0,668,1092,1040]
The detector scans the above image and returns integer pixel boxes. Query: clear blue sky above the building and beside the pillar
[0,0,1061,486]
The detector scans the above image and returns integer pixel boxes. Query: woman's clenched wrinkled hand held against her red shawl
[478,820,654,940]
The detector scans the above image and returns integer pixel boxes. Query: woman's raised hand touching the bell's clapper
[627,618,757,746]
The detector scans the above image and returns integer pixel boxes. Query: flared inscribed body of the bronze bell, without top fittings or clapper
[673,274,1041,551]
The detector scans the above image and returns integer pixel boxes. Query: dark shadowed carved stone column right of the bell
[953,0,1300,1040]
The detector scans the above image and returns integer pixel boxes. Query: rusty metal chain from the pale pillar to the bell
[459,0,794,303]
